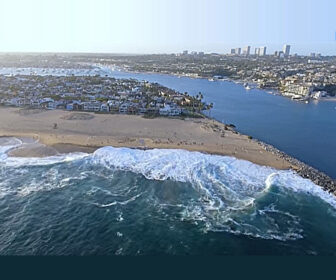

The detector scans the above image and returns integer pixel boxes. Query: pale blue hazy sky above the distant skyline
[0,0,336,55]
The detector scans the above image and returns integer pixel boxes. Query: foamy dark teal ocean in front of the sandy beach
[0,138,336,255]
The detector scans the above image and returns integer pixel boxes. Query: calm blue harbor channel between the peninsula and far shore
[107,71,336,178]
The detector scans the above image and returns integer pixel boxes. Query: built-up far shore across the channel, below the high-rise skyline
[102,51,336,101]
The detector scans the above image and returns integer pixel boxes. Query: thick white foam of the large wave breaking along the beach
[92,147,336,208]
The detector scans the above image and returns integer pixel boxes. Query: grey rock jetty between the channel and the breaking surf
[254,140,336,196]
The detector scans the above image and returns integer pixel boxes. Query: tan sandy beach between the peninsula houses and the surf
[0,107,296,169]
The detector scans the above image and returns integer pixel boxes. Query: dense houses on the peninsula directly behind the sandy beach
[0,75,204,117]
